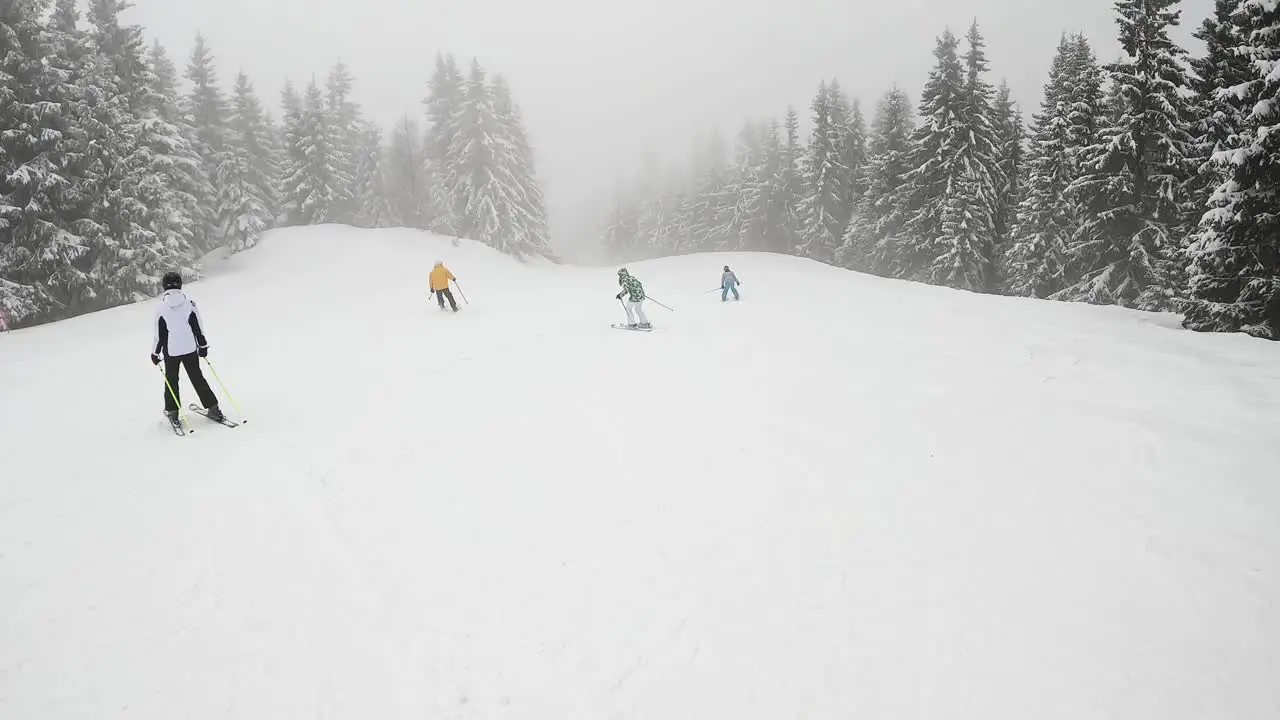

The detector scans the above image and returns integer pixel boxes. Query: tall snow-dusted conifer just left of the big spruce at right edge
[1053,0,1194,310]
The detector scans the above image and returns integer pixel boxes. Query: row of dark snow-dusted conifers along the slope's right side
[605,0,1280,340]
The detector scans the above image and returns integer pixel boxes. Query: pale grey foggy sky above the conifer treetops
[127,0,1212,260]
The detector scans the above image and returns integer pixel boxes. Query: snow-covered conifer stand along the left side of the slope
[0,0,550,327]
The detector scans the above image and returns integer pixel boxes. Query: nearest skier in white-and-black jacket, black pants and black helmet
[151,272,225,425]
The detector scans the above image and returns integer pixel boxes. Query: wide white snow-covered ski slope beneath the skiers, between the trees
[0,227,1280,720]
